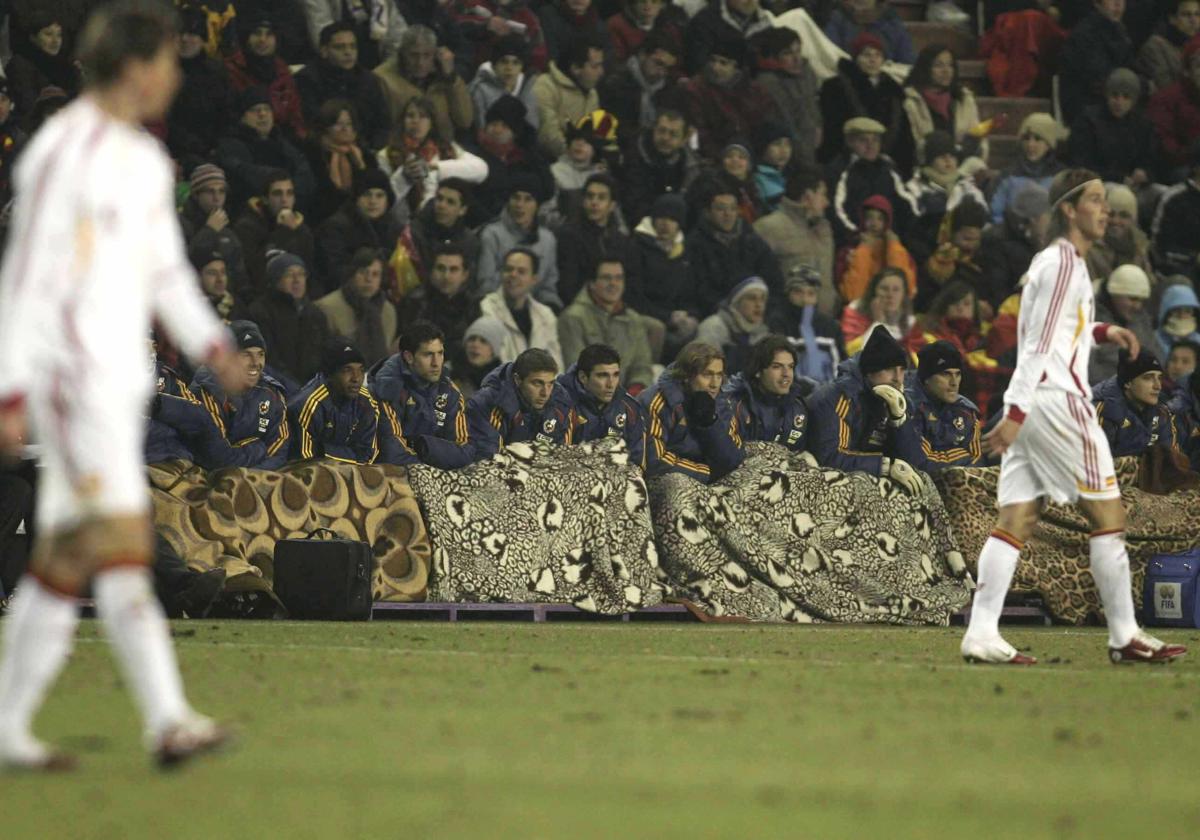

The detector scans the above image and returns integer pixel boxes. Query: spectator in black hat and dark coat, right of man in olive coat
[625,193,700,362]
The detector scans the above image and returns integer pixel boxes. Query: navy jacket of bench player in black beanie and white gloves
[809,354,925,475]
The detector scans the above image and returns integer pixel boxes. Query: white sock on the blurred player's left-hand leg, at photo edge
[0,575,79,761]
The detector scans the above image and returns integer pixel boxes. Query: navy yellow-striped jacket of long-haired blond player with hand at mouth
[637,365,744,484]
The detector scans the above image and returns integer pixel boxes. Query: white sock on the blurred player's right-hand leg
[94,566,190,736]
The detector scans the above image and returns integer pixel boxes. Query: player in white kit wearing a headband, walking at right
[961,169,1187,665]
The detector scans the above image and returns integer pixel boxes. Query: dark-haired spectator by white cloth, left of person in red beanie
[751,26,822,166]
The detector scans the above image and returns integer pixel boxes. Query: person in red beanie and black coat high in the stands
[817,34,912,163]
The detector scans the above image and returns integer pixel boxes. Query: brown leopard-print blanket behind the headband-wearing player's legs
[937,457,1200,624]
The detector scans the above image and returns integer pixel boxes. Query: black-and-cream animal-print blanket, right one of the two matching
[650,443,971,624]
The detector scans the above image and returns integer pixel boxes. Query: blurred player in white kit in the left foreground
[0,1,241,770]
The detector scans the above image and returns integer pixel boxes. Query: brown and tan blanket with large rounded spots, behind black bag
[149,461,430,601]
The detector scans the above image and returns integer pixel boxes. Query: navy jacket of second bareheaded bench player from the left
[467,361,571,461]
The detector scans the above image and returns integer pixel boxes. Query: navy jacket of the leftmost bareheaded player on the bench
[368,353,474,469]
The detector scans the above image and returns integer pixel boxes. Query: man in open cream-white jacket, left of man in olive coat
[479,246,563,369]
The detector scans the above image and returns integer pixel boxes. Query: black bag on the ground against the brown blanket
[274,528,376,622]
